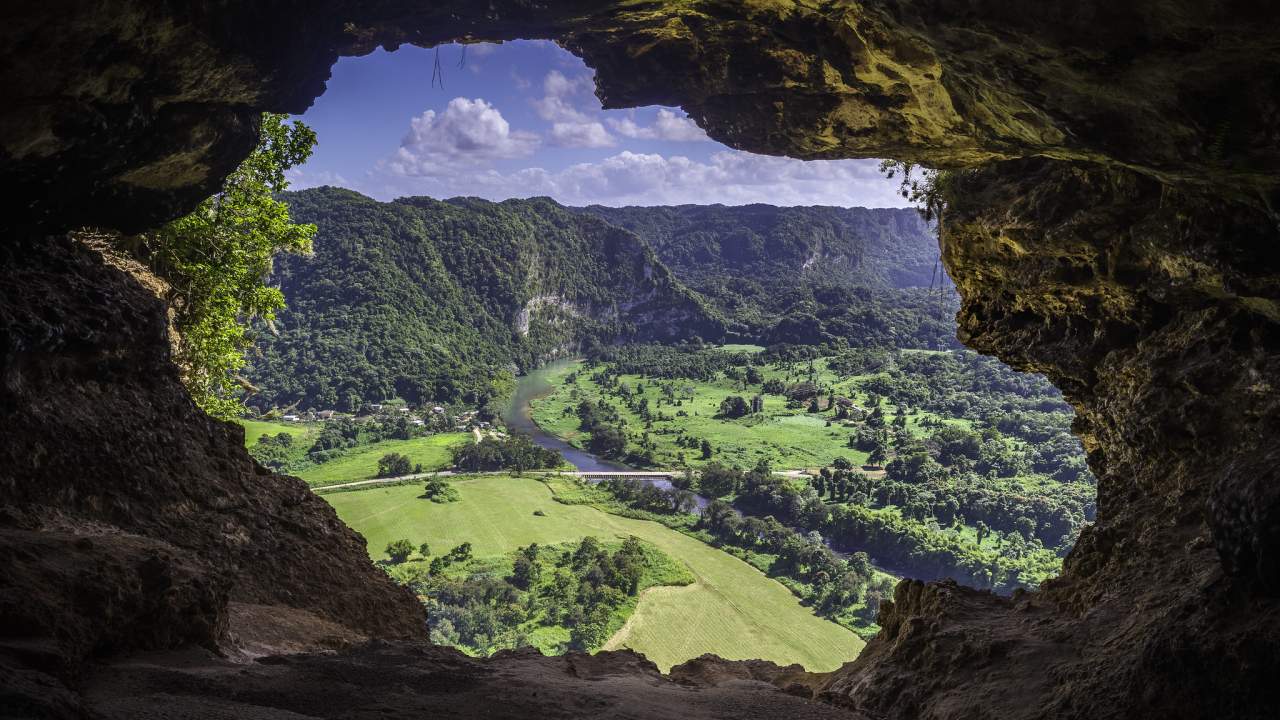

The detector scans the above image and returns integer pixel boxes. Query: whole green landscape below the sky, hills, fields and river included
[230,188,1096,670]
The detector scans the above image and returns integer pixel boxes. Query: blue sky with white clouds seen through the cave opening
[289,41,905,208]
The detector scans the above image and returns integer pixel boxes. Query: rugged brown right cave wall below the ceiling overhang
[824,160,1280,717]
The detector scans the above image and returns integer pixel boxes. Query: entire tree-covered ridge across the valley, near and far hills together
[246,187,955,410]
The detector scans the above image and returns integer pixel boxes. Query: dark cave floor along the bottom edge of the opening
[82,642,860,720]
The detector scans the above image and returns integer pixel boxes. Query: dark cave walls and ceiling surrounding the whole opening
[0,0,1280,719]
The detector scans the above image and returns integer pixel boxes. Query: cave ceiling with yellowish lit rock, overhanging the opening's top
[0,0,1280,229]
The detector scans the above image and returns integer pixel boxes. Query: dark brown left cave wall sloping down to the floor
[0,238,426,679]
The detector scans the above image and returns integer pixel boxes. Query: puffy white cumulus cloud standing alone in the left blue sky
[385,97,539,176]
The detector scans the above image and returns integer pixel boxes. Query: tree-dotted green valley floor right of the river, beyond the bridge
[519,346,1096,592]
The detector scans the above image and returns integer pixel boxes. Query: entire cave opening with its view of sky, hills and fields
[225,41,1096,671]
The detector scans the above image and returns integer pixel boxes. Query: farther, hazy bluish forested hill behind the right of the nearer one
[577,205,959,348]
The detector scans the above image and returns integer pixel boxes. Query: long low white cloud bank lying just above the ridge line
[365,150,905,208]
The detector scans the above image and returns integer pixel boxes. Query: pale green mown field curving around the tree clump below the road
[325,475,863,671]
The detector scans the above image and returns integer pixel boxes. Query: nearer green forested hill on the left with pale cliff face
[246,187,723,409]
